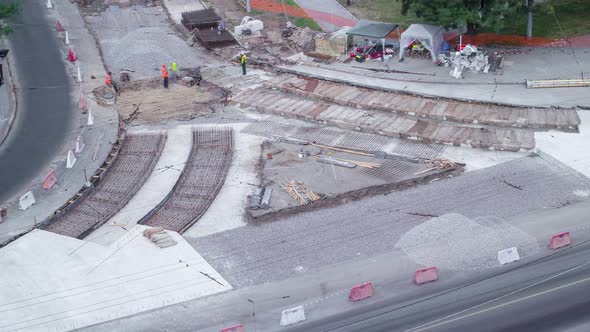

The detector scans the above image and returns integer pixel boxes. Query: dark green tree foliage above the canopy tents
[402,0,527,33]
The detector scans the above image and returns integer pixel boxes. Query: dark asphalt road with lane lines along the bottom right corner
[287,244,590,332]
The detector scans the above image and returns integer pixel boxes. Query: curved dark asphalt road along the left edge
[0,0,75,203]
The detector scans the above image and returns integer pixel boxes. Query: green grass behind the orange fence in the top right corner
[489,0,590,38]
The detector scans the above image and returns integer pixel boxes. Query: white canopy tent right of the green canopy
[399,24,444,62]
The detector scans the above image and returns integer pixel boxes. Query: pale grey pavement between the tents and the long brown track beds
[279,44,590,108]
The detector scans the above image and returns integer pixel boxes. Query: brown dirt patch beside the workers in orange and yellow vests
[116,80,223,124]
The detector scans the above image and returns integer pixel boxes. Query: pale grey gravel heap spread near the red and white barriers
[396,213,540,270]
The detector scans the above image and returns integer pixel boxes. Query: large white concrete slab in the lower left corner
[0,226,232,331]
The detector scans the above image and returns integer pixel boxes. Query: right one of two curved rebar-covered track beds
[140,128,233,233]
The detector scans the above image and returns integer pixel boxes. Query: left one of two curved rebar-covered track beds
[45,133,166,239]
